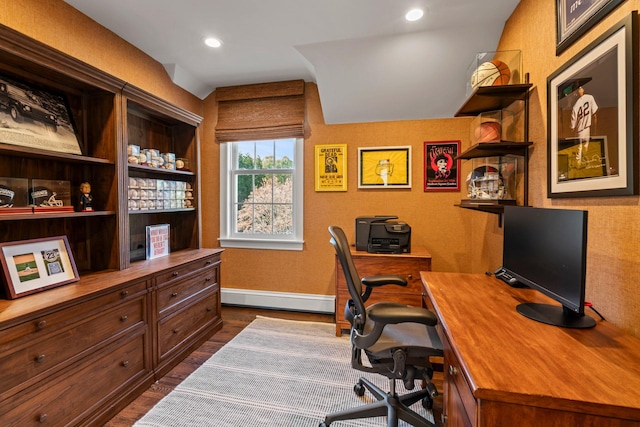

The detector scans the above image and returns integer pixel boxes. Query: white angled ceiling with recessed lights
[66,0,519,124]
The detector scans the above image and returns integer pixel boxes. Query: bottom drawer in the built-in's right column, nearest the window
[158,284,220,361]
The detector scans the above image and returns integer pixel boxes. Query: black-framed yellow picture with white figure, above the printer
[358,146,411,188]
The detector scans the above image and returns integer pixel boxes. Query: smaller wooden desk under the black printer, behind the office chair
[336,245,431,336]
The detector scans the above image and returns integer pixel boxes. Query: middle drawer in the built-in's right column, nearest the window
[156,265,218,316]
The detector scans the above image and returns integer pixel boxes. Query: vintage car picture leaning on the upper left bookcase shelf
[0,75,82,154]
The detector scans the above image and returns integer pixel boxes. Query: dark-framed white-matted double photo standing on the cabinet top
[0,236,80,299]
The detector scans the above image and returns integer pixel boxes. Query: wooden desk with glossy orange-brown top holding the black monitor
[421,272,640,427]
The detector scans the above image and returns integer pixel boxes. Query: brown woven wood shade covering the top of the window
[216,80,305,142]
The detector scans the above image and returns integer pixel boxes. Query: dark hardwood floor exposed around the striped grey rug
[105,306,442,427]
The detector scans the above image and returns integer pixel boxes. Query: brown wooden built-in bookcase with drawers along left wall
[0,26,222,426]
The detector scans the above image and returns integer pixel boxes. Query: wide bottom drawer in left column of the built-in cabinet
[0,328,148,427]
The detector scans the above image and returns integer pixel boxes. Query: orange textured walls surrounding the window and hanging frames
[0,0,640,342]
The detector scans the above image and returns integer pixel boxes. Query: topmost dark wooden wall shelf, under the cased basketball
[455,83,533,117]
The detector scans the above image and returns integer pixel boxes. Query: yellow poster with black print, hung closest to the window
[315,144,347,191]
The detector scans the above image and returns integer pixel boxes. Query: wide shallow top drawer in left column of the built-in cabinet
[0,281,147,357]
